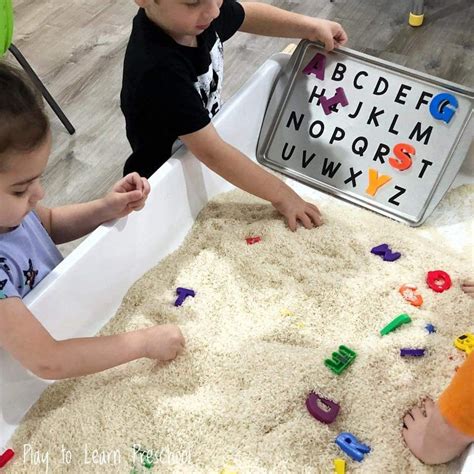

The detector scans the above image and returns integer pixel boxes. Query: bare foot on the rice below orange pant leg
[402,398,474,464]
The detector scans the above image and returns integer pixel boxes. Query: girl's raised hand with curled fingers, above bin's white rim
[104,173,150,219]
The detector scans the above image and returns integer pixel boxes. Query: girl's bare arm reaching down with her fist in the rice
[0,298,184,380]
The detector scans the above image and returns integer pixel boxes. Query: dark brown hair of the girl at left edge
[0,61,49,170]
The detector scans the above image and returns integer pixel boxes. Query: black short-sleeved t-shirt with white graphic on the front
[120,0,245,177]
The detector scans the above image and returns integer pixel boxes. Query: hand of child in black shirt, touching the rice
[272,186,323,231]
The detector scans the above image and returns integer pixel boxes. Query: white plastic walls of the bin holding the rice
[0,53,474,474]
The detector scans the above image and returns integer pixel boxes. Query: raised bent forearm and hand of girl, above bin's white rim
[36,173,150,244]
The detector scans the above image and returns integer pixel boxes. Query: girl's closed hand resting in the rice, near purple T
[144,324,184,361]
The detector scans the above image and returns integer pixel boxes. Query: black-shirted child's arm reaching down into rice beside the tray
[180,124,321,230]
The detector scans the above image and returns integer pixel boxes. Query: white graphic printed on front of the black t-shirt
[194,33,224,118]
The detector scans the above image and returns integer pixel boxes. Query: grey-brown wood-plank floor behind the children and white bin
[7,0,474,253]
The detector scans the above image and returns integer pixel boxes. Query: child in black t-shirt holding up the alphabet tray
[121,0,347,230]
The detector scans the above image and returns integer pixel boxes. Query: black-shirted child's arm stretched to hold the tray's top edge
[239,2,347,50]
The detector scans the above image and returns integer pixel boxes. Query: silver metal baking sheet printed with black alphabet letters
[257,41,474,226]
